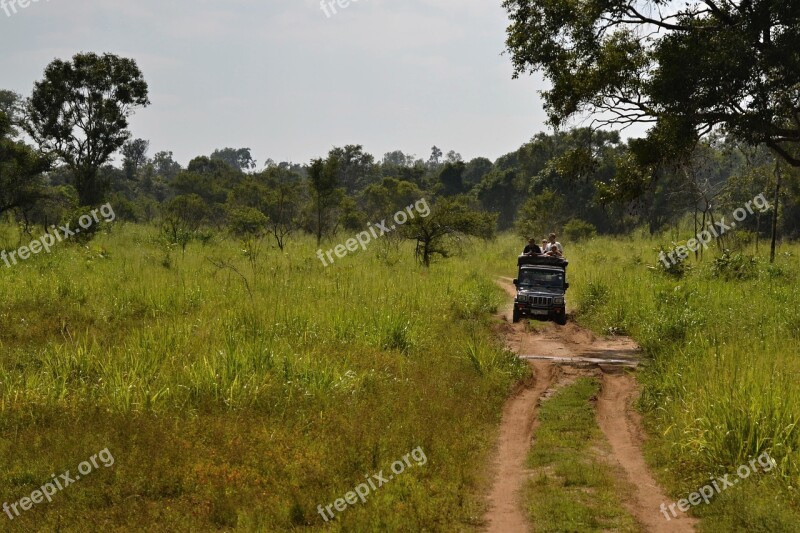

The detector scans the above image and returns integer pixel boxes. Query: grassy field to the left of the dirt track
[0,222,528,531]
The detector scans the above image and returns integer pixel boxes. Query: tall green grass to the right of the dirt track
[570,233,800,531]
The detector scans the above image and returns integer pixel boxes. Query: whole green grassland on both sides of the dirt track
[0,219,800,531]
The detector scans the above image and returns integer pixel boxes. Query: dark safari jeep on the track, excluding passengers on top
[513,255,569,325]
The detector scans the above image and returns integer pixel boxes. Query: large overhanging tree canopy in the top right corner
[503,0,800,166]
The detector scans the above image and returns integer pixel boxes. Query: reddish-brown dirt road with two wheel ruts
[484,278,695,533]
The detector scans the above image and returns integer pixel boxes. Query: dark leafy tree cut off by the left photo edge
[0,111,50,219]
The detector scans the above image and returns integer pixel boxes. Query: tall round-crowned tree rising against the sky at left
[23,53,150,205]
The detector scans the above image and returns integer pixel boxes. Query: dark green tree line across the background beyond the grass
[0,54,800,263]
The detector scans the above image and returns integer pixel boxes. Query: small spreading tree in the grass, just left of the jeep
[401,196,497,267]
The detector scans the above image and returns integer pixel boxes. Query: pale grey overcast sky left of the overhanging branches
[0,0,564,165]
